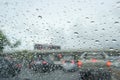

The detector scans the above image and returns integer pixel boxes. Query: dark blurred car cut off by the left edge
[0,57,20,77]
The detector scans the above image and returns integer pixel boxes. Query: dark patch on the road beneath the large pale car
[80,69,116,80]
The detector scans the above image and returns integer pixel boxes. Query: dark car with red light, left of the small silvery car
[29,57,55,72]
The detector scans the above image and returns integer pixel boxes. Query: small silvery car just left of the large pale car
[61,60,78,72]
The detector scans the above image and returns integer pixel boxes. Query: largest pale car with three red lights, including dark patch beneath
[77,51,112,80]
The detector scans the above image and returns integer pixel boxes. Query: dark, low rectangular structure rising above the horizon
[34,44,61,50]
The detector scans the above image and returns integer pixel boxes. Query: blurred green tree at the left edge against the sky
[0,30,21,52]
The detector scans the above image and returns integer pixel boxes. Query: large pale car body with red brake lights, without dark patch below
[78,52,109,68]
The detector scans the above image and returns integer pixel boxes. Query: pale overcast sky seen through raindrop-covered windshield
[0,0,120,50]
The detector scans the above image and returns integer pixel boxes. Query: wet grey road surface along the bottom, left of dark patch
[0,68,117,80]
